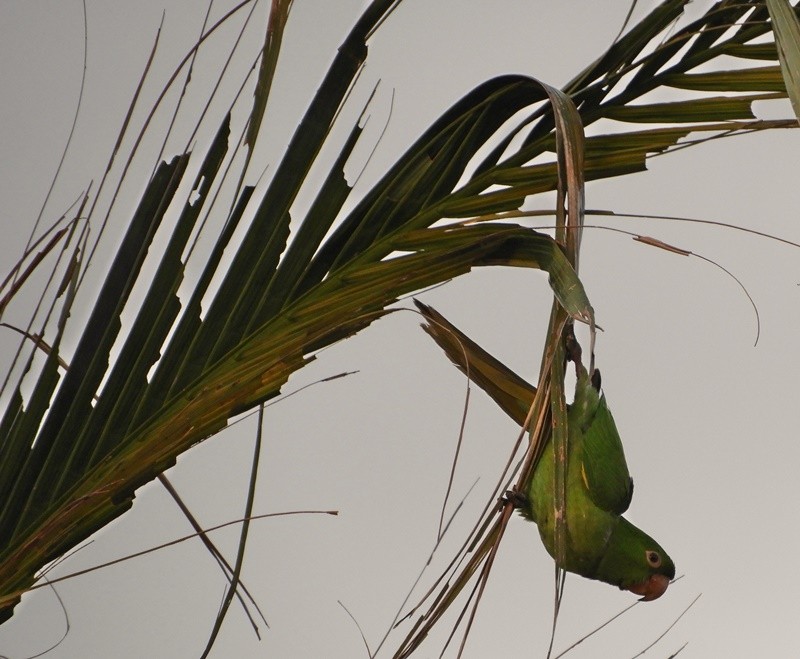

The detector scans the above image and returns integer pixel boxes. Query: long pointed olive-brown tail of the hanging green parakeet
[414,300,536,426]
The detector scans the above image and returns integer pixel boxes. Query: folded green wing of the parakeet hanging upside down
[569,366,633,515]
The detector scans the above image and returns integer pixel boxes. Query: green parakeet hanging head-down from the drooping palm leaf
[416,302,675,600]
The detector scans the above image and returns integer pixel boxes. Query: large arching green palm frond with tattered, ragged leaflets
[0,0,795,620]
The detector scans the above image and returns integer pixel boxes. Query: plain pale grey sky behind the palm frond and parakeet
[0,0,800,659]
